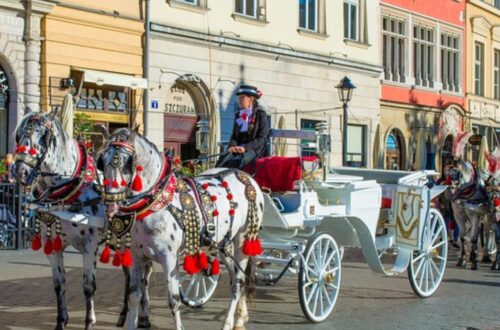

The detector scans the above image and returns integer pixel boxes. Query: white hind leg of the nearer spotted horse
[222,235,248,330]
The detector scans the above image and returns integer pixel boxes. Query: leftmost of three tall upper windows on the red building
[382,17,408,83]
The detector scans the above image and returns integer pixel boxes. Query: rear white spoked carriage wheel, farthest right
[408,209,448,298]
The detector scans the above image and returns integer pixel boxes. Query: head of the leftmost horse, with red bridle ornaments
[14,108,65,185]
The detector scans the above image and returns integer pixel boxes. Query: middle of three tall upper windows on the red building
[413,25,435,88]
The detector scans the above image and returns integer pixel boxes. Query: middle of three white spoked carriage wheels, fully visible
[299,233,341,323]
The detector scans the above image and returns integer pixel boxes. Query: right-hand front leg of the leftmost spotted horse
[82,239,98,330]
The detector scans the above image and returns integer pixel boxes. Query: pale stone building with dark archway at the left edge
[0,0,53,156]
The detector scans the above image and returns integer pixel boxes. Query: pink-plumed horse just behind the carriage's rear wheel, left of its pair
[451,132,493,270]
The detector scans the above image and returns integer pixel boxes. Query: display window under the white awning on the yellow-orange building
[76,83,131,114]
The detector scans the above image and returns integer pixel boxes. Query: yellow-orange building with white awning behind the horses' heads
[41,0,147,144]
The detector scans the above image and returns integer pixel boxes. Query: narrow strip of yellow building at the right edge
[466,0,500,151]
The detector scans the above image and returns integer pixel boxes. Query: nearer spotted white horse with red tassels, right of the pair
[97,129,264,330]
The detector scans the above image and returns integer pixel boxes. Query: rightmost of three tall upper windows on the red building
[441,33,460,92]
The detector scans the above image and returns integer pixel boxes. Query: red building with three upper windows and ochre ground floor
[377,0,467,171]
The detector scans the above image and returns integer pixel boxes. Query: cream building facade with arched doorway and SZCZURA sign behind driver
[148,0,382,167]
